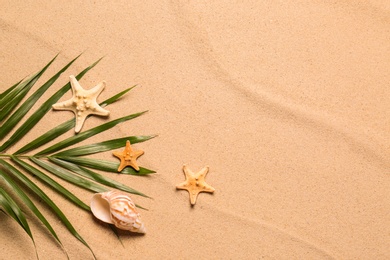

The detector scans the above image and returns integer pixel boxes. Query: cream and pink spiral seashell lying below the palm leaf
[91,191,146,233]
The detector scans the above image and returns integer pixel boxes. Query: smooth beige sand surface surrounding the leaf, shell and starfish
[0,0,390,259]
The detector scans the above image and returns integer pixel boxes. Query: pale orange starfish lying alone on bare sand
[176,165,215,205]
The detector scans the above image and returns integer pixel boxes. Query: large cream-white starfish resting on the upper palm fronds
[53,75,110,133]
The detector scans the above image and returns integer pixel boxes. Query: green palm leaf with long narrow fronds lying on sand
[0,56,155,257]
